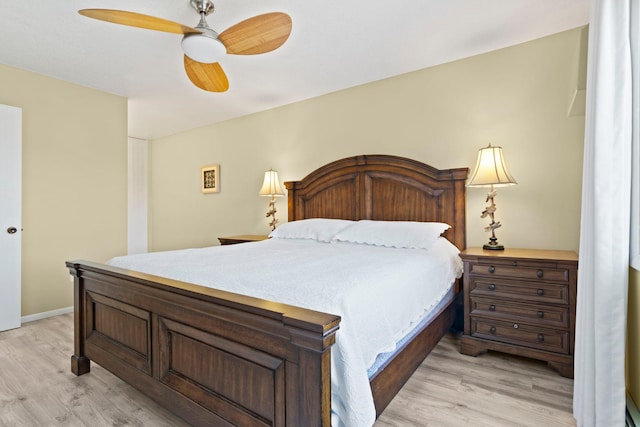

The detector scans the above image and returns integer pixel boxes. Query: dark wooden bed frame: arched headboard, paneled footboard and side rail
[67,155,468,426]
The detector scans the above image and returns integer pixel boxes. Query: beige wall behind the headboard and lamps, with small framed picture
[150,29,584,254]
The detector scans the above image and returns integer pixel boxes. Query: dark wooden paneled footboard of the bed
[67,261,340,427]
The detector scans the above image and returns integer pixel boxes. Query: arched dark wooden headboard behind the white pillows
[285,155,469,250]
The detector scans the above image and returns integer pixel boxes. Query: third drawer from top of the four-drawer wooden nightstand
[471,298,569,328]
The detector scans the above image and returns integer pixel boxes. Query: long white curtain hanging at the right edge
[573,0,640,427]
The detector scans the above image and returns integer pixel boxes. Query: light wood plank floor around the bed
[0,314,575,427]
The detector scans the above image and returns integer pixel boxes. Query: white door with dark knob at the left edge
[0,105,22,331]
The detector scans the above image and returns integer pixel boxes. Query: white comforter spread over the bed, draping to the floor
[109,238,462,427]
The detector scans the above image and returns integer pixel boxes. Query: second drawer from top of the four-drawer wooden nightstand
[469,277,569,304]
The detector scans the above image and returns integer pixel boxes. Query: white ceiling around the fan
[0,0,589,139]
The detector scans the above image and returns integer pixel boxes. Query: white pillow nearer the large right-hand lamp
[333,220,451,249]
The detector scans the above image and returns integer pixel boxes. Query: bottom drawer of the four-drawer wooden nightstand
[471,317,569,354]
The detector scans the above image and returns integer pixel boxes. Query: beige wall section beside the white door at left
[0,65,127,316]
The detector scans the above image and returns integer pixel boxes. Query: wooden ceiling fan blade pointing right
[218,12,291,55]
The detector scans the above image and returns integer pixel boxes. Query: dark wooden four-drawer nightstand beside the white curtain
[460,248,578,378]
